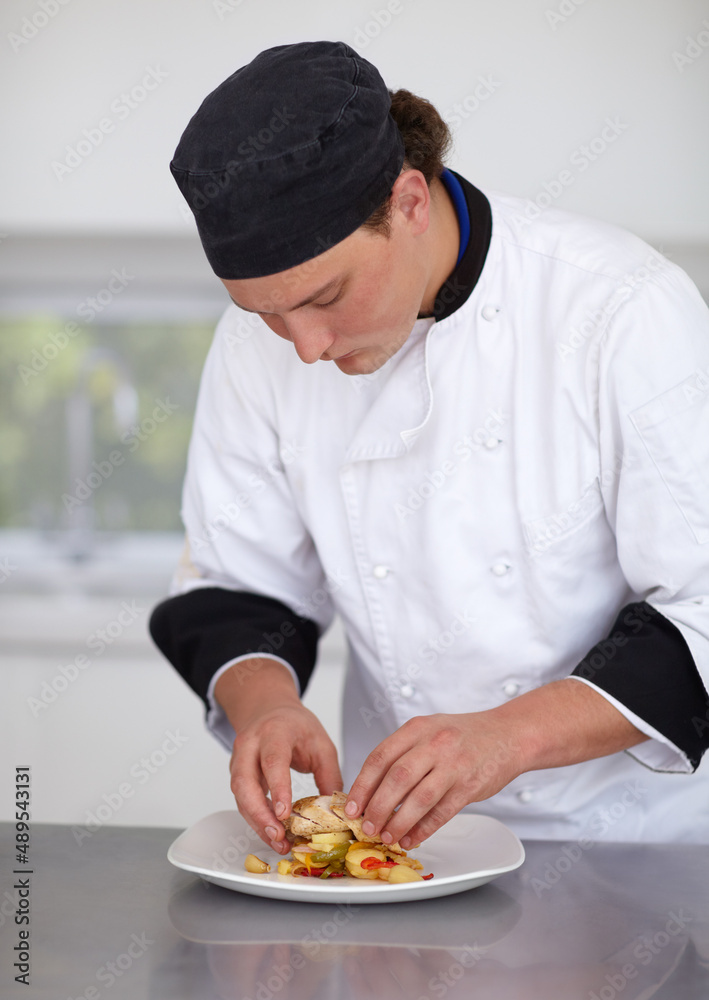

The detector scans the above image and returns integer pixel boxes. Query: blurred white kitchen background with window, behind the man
[0,0,709,830]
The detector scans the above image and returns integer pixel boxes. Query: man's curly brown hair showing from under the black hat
[361,90,453,239]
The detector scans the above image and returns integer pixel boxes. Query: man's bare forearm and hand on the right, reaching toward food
[345,678,647,849]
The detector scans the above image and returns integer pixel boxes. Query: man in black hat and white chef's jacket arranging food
[151,42,709,852]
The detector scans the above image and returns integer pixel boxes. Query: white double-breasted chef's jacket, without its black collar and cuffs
[173,192,709,842]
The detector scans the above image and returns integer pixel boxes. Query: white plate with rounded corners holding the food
[167,810,524,903]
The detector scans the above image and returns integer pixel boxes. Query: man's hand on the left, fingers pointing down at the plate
[214,657,342,854]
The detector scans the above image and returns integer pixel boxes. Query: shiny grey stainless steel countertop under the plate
[0,824,709,1000]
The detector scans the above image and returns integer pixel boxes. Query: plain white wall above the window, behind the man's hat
[0,0,709,244]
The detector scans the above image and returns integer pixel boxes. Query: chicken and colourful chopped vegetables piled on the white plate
[245,792,433,884]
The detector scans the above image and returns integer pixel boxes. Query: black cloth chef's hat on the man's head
[170,42,404,278]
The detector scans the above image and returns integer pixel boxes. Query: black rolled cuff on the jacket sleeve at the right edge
[572,601,709,770]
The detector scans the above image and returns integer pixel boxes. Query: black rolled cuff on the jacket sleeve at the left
[150,587,319,708]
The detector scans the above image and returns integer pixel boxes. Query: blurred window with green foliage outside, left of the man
[0,316,214,531]
